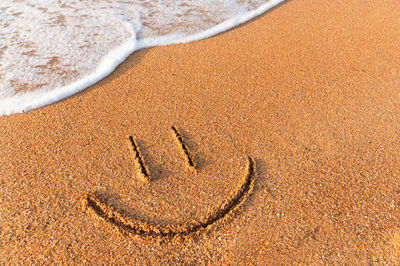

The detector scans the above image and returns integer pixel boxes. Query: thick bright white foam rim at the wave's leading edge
[0,0,286,115]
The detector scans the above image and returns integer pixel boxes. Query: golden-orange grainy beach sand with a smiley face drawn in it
[0,0,400,265]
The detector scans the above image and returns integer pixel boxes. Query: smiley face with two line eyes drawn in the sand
[82,126,255,241]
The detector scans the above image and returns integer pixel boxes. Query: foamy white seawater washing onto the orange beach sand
[0,0,284,115]
